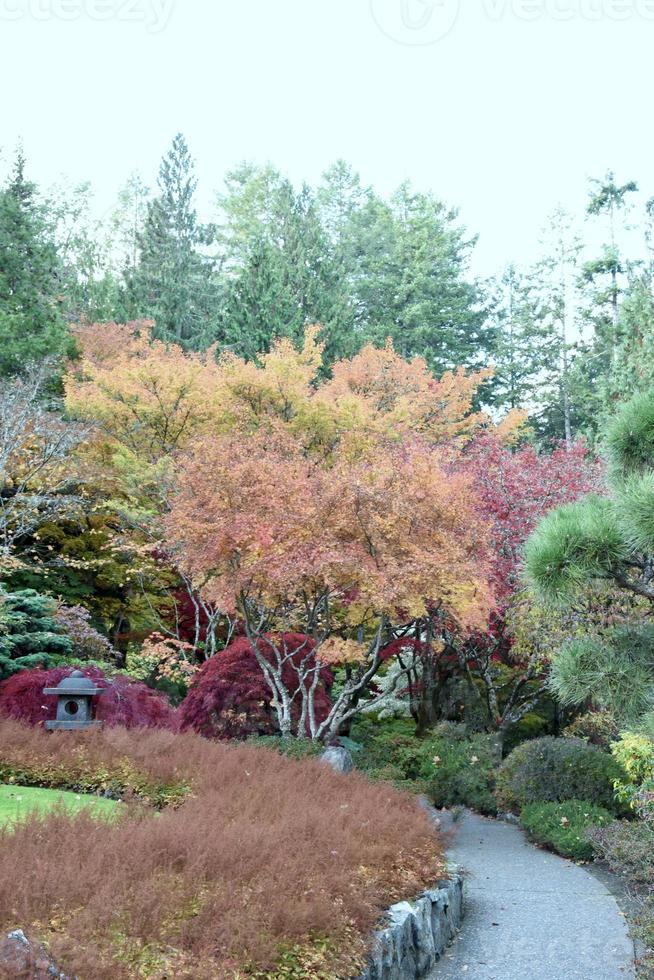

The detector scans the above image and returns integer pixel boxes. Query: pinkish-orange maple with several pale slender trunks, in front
[165,432,491,739]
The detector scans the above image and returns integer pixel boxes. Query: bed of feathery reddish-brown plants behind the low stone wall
[0,721,442,980]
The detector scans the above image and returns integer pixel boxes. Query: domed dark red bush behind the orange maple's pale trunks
[179,633,333,739]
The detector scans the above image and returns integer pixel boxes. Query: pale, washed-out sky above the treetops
[0,0,654,273]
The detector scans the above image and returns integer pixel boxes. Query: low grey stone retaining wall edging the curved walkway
[358,865,464,980]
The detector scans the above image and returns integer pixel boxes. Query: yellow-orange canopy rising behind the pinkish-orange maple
[64,321,520,466]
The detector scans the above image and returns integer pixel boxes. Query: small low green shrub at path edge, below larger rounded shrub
[520,800,614,861]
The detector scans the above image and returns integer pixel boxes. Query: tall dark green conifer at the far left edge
[0,150,68,375]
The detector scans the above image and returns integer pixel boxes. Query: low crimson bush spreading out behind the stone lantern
[0,667,177,730]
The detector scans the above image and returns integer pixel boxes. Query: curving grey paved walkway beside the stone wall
[429,813,634,980]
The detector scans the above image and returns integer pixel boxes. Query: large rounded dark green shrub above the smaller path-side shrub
[496,736,625,813]
